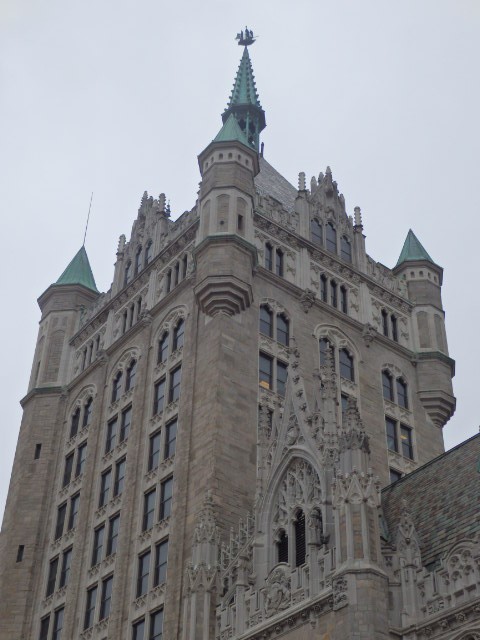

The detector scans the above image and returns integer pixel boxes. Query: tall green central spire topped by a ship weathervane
[222,27,266,152]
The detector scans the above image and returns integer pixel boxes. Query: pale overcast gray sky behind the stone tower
[0,0,480,514]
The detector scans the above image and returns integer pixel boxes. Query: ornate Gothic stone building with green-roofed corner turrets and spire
[0,35,480,640]
